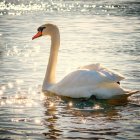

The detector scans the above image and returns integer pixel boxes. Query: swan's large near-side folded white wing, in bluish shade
[49,70,111,98]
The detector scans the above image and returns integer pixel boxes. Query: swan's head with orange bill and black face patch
[32,24,59,40]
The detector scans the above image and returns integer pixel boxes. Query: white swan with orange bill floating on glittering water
[32,23,138,99]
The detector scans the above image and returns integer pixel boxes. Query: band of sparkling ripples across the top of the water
[0,0,139,16]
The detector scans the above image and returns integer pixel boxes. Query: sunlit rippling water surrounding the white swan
[0,0,140,140]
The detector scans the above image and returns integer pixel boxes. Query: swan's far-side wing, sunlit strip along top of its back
[79,63,124,82]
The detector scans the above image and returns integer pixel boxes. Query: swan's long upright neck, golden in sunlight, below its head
[43,28,60,86]
